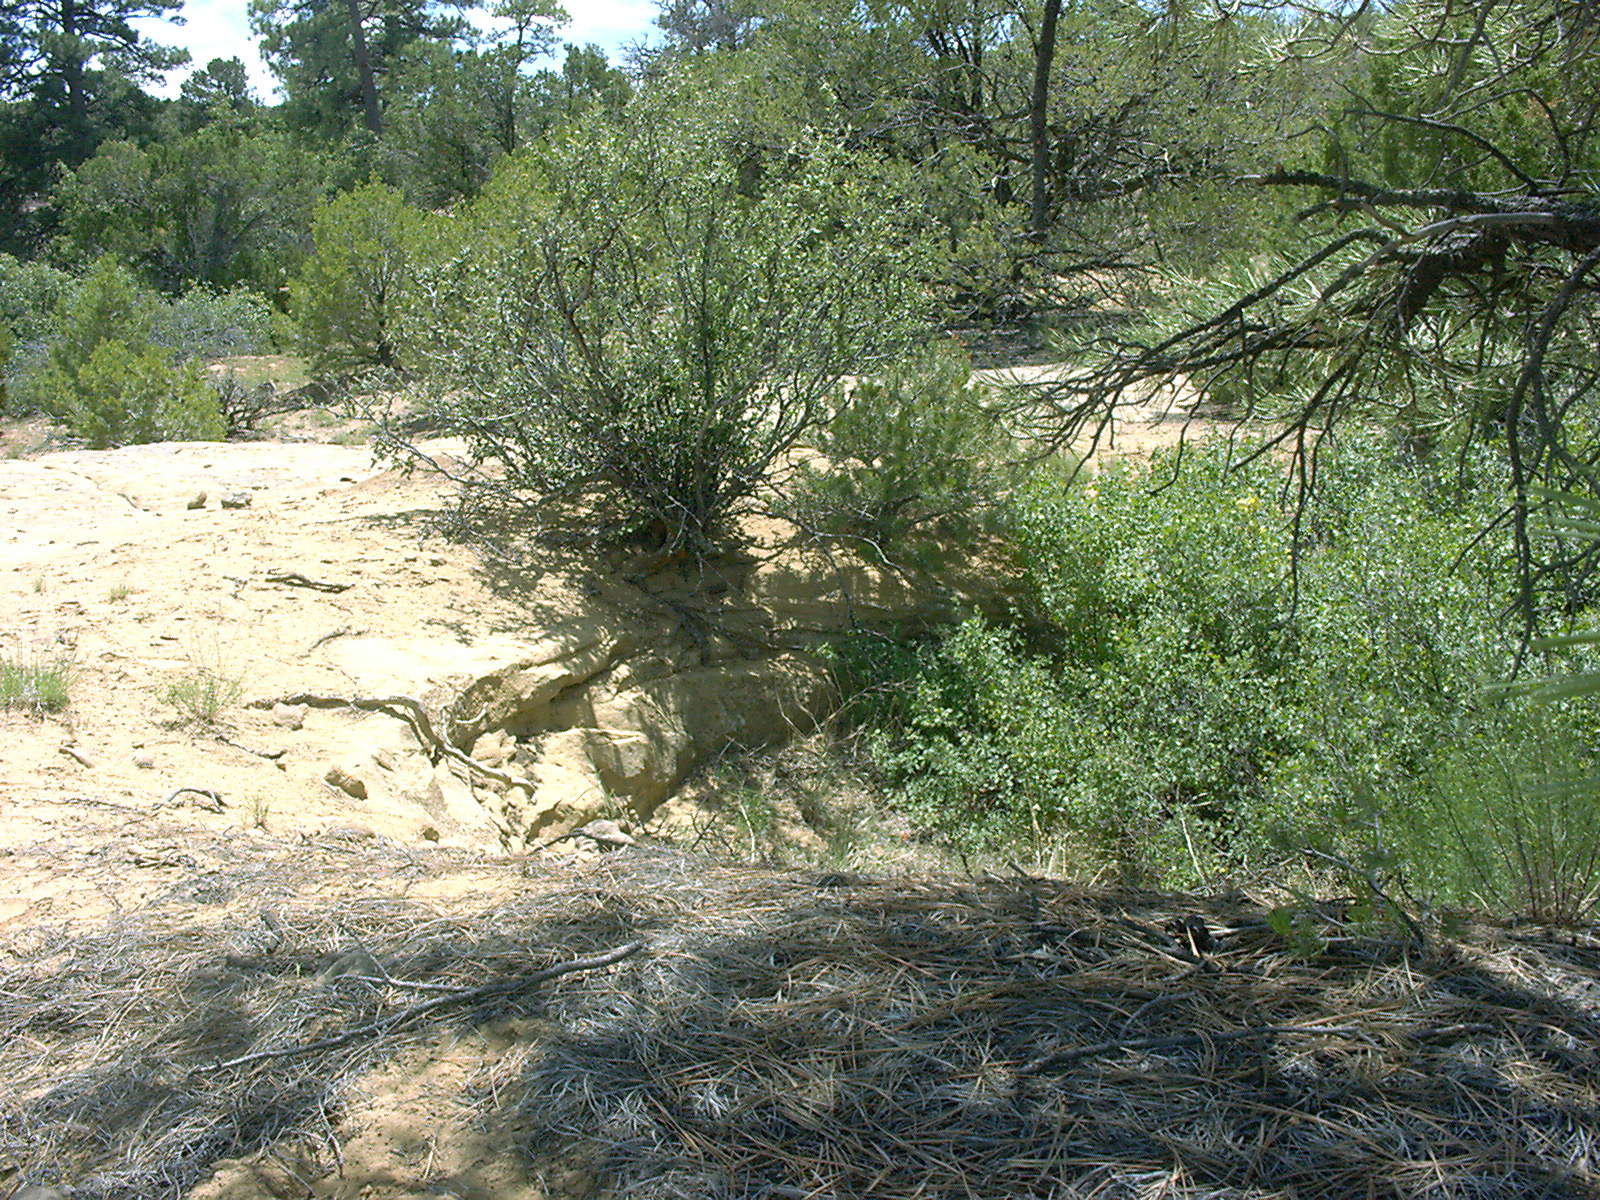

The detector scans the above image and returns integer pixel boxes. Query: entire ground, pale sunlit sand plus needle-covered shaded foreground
[0,371,1600,1200]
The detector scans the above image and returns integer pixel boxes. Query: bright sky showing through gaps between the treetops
[133,0,656,99]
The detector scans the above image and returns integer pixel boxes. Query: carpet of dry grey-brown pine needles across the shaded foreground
[0,843,1600,1200]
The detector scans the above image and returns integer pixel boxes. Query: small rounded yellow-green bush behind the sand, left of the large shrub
[290,182,422,374]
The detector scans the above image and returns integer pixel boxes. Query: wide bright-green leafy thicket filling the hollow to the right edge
[840,438,1600,912]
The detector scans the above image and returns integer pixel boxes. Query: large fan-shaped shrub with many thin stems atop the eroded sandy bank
[421,88,923,552]
